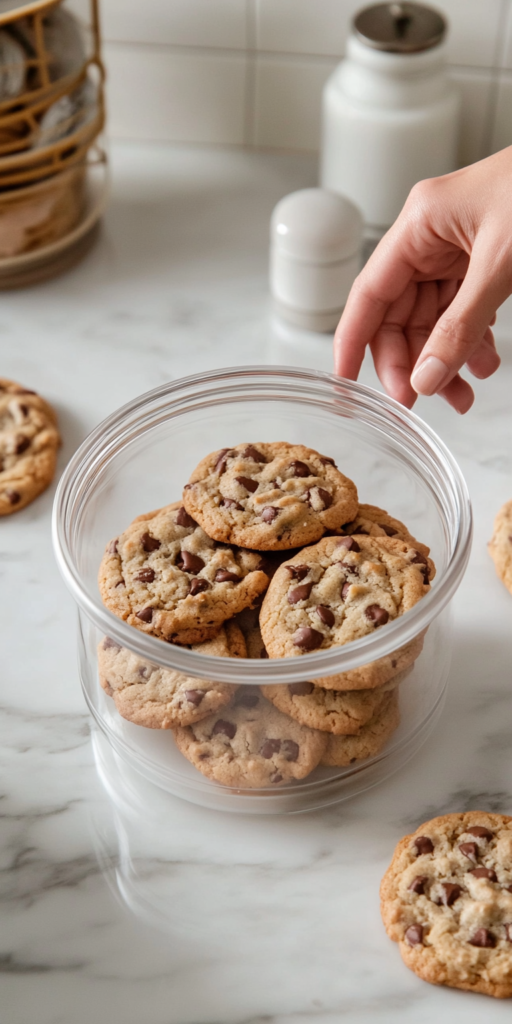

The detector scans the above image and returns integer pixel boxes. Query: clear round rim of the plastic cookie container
[52,366,472,684]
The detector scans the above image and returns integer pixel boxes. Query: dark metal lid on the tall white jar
[353,3,446,53]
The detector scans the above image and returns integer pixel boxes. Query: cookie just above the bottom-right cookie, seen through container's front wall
[260,673,404,736]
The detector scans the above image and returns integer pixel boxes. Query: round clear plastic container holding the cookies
[53,367,472,814]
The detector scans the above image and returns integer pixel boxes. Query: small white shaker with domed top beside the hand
[270,188,362,332]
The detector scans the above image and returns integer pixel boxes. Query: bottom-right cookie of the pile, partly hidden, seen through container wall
[321,688,400,768]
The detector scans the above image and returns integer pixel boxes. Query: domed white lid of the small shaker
[270,188,362,263]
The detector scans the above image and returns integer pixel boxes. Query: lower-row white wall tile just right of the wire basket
[105,43,247,145]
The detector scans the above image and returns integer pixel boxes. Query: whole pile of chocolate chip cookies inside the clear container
[98,441,435,787]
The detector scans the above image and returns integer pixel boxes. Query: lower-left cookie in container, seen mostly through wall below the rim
[97,622,247,729]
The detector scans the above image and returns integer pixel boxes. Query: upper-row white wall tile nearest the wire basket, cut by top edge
[101,0,247,50]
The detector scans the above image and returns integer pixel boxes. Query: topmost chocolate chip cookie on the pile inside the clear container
[183,441,357,551]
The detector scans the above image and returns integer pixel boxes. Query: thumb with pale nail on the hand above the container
[411,234,512,395]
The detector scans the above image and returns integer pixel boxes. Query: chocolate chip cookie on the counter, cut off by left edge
[0,377,60,515]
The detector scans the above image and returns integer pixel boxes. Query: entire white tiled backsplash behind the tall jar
[101,0,512,158]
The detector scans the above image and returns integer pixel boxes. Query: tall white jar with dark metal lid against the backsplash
[321,3,459,238]
